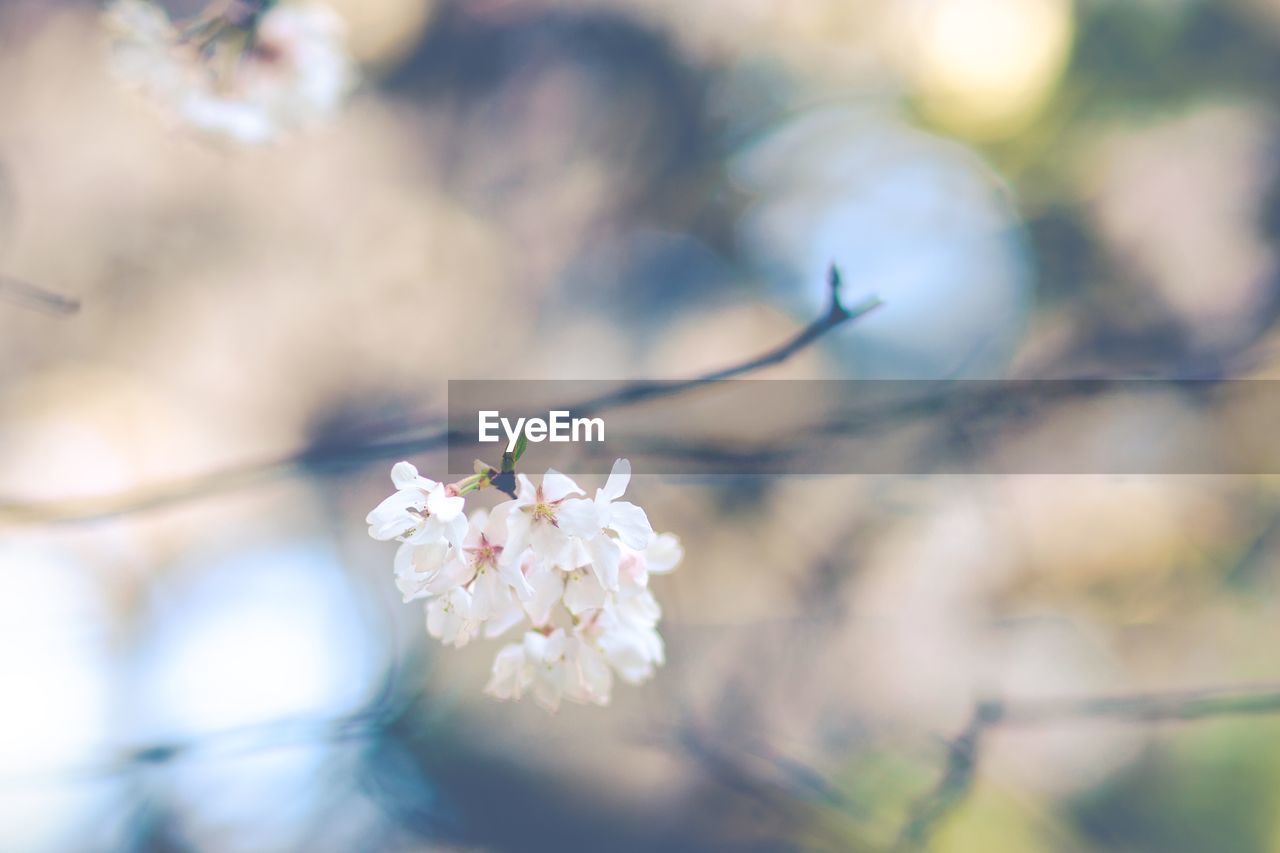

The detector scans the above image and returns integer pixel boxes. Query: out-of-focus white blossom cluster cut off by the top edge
[105,0,356,143]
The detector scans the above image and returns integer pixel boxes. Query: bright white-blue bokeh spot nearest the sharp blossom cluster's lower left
[134,546,383,736]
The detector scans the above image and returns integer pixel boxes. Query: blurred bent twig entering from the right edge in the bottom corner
[899,684,1280,850]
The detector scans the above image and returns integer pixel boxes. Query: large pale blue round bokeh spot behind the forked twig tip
[735,109,1032,378]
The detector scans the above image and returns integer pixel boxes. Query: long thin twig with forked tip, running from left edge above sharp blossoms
[0,266,881,528]
